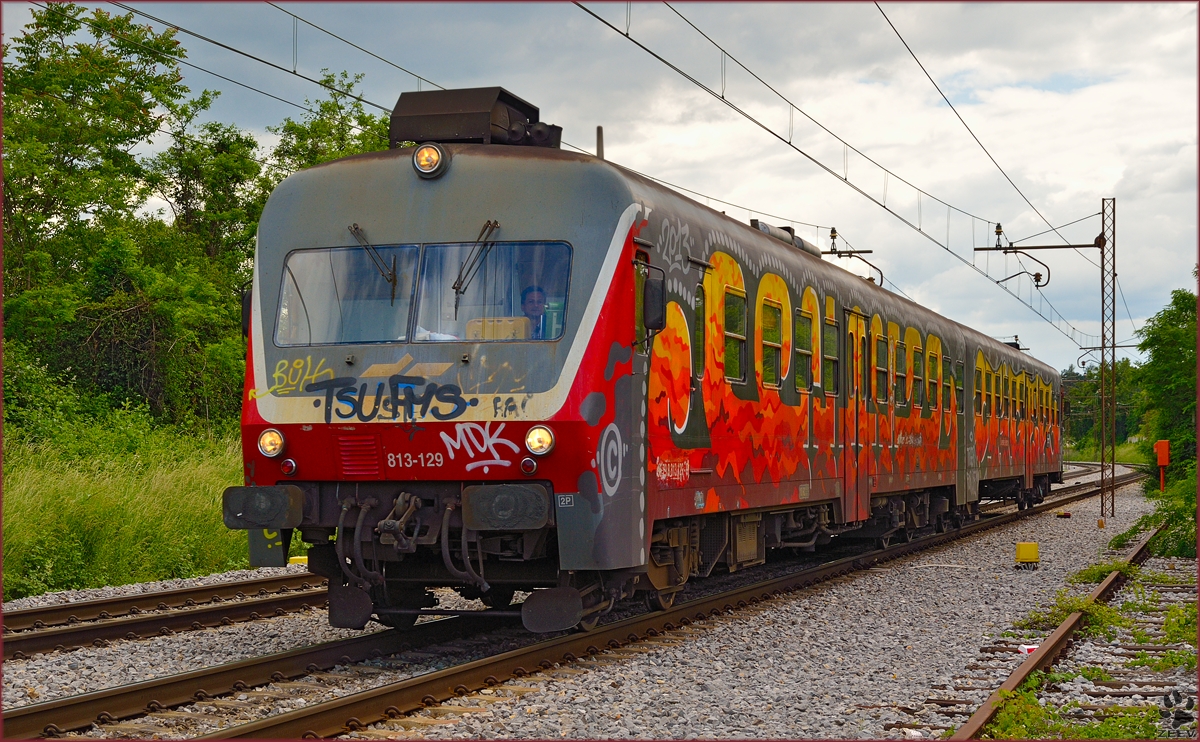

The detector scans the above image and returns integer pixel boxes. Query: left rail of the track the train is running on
[4,609,511,740]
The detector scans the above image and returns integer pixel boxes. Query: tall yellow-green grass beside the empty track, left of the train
[2,409,247,600]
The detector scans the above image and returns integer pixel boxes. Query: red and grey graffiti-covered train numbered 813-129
[222,88,1062,632]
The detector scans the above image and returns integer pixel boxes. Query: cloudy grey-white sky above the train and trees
[2,2,1200,369]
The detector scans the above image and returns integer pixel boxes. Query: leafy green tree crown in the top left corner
[0,4,187,294]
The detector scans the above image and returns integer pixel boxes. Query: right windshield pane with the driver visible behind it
[413,243,571,342]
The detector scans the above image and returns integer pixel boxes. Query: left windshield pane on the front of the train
[275,245,418,347]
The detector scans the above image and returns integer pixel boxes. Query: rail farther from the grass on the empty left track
[4,587,328,659]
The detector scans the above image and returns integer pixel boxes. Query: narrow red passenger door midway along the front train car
[842,307,871,522]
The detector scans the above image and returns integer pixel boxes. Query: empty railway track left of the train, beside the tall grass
[4,574,326,659]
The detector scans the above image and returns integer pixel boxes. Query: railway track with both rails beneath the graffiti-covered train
[4,474,1138,738]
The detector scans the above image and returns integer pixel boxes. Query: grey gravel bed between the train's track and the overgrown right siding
[391,485,1151,738]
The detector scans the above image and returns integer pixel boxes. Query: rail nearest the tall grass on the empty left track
[0,573,328,634]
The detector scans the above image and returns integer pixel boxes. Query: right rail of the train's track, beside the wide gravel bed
[198,477,1142,740]
